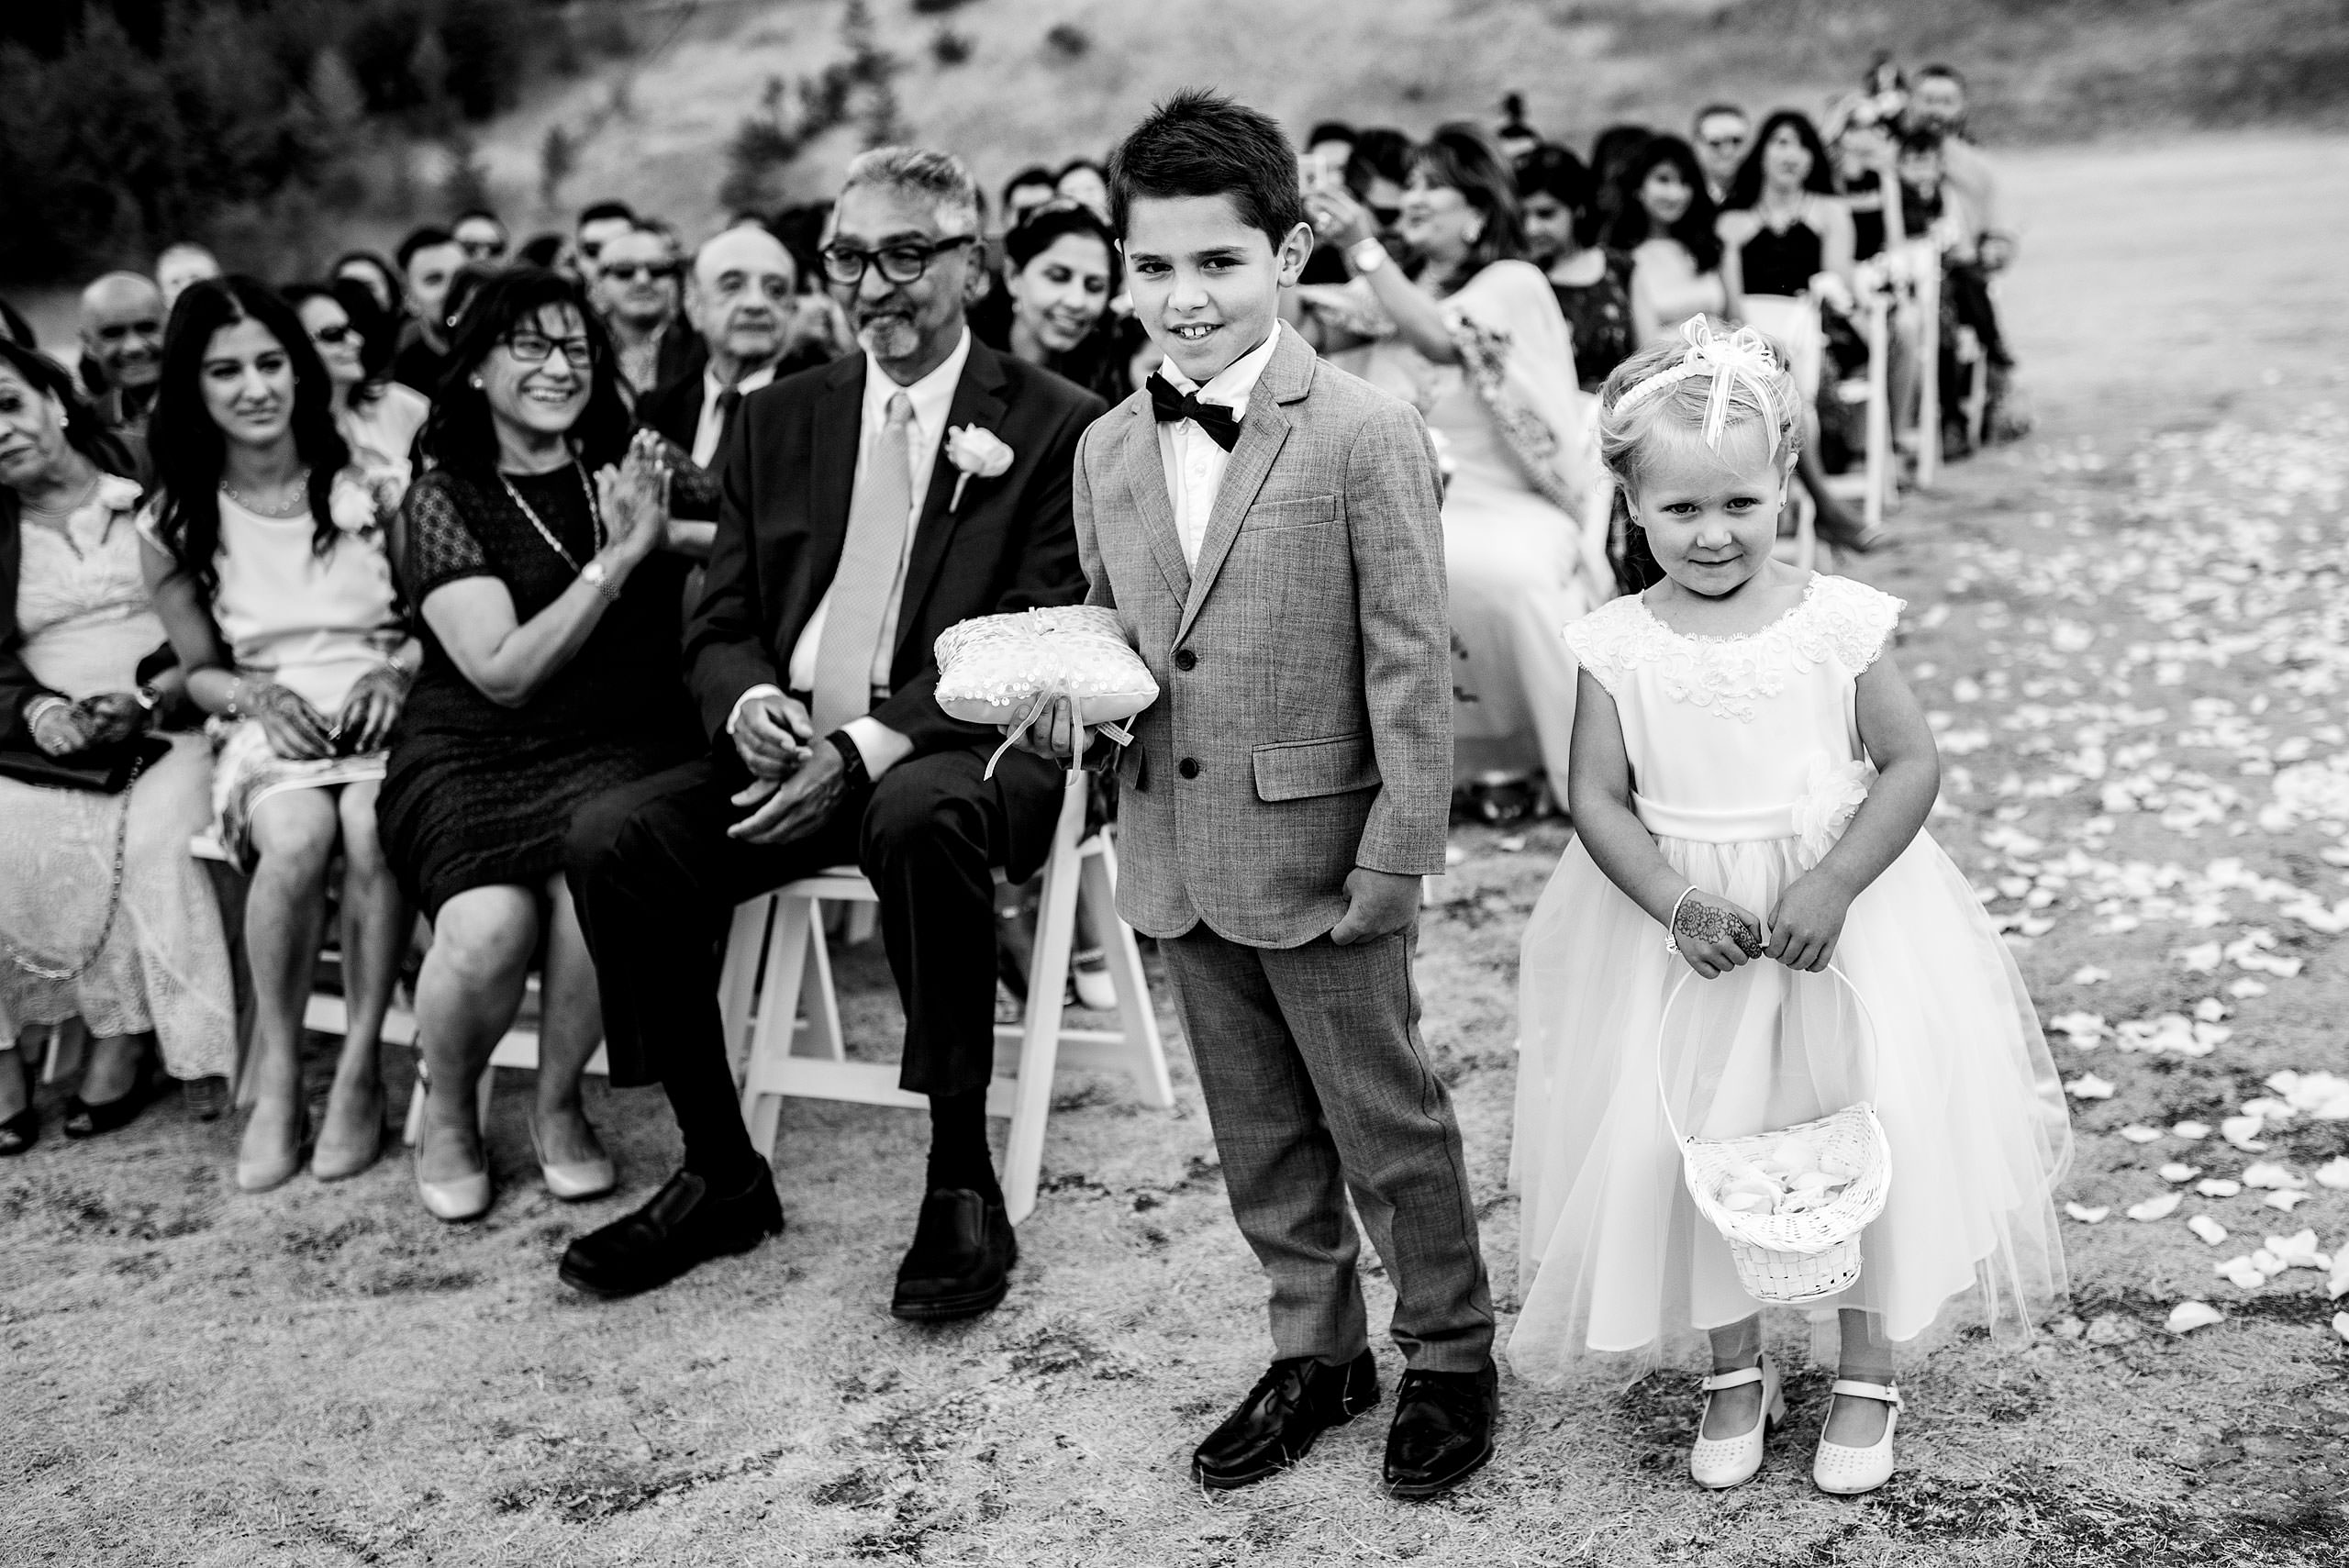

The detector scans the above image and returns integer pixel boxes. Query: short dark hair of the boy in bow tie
[1108,87,1306,251]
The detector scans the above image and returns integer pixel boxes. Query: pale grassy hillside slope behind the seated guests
[458,0,2349,241]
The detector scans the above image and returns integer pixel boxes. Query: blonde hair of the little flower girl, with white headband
[1599,317,1802,594]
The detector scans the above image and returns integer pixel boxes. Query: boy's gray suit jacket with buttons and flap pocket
[1074,328,1452,949]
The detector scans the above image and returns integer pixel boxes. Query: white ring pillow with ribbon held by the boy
[937,606,1158,774]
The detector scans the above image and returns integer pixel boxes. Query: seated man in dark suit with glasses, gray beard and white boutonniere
[562,148,1104,1321]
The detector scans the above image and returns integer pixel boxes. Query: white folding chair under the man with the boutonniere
[718,773,1174,1223]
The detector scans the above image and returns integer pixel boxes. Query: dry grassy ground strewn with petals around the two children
[0,139,2349,1568]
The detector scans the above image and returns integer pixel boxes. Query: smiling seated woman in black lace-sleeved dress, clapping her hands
[378,272,700,1220]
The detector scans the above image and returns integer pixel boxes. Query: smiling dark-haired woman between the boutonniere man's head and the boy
[970,202,1134,401]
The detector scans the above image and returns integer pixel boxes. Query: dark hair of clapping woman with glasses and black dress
[416,268,632,481]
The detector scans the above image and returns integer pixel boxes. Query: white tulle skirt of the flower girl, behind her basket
[1508,833,2072,1383]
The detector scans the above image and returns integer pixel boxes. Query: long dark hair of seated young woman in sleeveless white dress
[148,272,350,598]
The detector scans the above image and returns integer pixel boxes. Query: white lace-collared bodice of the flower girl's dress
[1567,575,1903,842]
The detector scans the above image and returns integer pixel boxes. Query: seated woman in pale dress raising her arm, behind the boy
[1306,125,1614,800]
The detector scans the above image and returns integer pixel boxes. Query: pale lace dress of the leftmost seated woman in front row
[0,476,238,1077]
